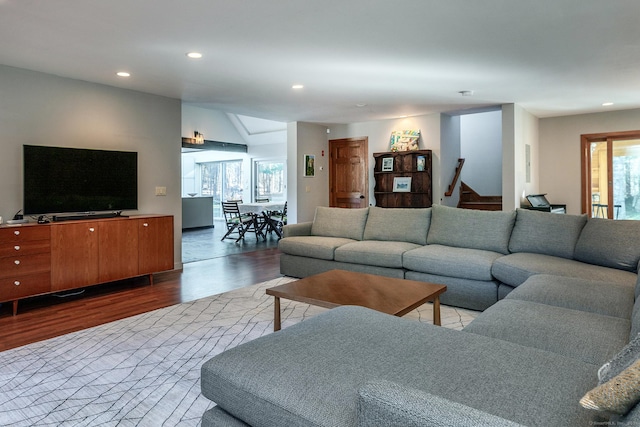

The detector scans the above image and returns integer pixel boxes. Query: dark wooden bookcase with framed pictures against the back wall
[373,150,433,208]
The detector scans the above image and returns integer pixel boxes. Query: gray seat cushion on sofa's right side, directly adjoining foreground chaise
[463,300,631,369]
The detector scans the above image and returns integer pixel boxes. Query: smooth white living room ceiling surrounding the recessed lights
[0,0,640,124]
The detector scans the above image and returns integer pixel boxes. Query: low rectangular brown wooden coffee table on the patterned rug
[266,270,447,331]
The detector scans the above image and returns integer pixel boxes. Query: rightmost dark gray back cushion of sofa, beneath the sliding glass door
[573,218,640,272]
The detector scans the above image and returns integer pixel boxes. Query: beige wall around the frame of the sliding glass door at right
[540,109,640,214]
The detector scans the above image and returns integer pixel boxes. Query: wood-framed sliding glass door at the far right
[582,131,640,219]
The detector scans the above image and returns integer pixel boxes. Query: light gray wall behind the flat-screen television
[0,66,182,268]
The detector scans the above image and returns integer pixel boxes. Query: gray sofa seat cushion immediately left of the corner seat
[403,244,503,280]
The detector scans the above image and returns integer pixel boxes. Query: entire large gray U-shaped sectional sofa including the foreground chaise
[201,206,640,426]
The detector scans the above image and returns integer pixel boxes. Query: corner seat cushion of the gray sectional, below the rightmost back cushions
[491,252,637,287]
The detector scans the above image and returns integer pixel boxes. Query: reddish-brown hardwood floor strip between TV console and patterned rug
[0,241,281,351]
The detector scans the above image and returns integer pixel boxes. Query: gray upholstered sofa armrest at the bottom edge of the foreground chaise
[358,380,520,427]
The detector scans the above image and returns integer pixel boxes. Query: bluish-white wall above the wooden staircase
[460,111,502,196]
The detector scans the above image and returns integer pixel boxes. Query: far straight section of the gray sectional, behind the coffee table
[279,205,640,310]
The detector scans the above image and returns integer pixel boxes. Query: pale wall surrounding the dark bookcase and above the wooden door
[328,114,448,204]
